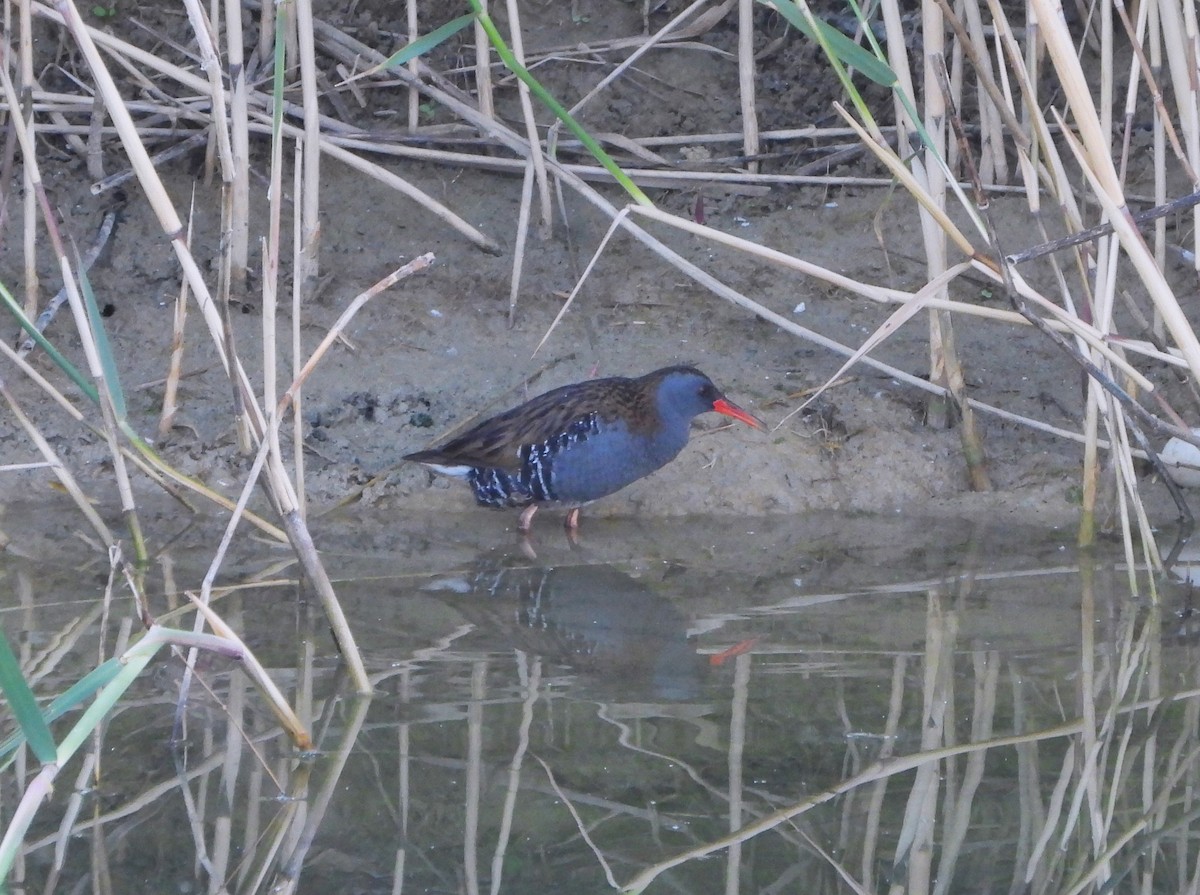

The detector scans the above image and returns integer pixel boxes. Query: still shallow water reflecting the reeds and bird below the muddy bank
[7,513,1200,895]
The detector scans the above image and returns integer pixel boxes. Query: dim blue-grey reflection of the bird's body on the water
[426,565,707,702]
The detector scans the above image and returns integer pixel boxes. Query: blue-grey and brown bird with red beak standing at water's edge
[404,367,763,531]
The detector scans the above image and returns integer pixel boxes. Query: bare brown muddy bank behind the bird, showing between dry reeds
[0,3,1170,532]
